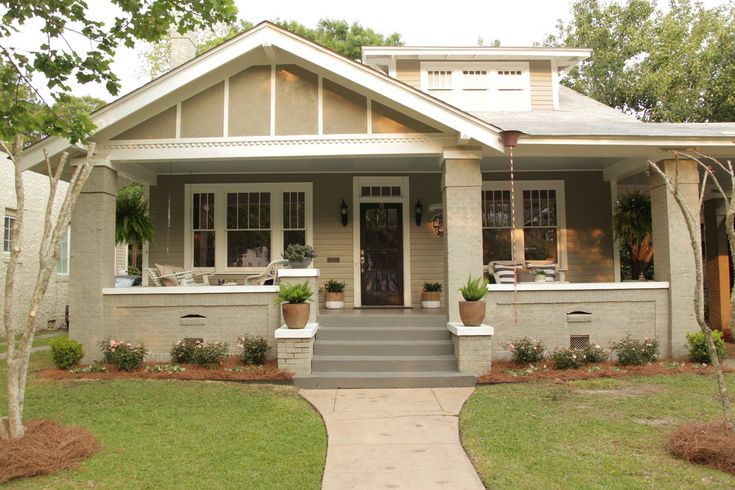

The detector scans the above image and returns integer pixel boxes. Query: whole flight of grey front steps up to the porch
[294,312,476,388]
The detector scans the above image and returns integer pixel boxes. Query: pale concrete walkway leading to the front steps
[301,388,484,490]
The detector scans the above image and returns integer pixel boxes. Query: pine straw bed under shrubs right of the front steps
[478,360,732,385]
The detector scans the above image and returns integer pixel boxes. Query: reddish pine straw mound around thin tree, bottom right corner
[668,420,735,475]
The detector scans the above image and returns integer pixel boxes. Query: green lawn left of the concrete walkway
[0,352,327,489]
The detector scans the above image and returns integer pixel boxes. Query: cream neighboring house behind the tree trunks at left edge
[0,159,70,333]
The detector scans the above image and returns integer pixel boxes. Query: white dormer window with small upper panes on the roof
[421,62,531,112]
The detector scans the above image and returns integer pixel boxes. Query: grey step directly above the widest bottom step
[311,355,457,373]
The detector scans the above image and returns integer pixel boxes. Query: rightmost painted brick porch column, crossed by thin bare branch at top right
[650,160,699,357]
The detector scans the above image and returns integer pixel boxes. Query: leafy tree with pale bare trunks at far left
[0,0,237,439]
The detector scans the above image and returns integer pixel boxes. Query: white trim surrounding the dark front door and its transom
[352,176,412,307]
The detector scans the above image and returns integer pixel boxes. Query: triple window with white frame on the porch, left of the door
[184,182,312,273]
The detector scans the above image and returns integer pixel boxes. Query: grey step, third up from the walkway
[314,339,454,356]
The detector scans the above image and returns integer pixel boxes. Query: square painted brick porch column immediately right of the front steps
[442,149,483,322]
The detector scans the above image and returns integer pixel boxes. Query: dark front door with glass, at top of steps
[360,203,403,306]
